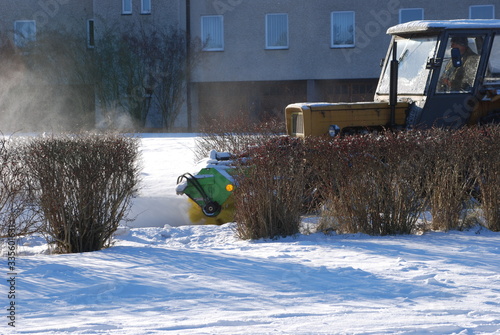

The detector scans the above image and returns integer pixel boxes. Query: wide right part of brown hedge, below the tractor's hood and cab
[316,126,500,235]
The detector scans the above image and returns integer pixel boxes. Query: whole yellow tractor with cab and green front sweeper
[177,20,500,224]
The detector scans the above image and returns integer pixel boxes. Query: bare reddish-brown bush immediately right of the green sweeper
[234,137,308,239]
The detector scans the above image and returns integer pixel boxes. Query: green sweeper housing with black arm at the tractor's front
[176,151,235,224]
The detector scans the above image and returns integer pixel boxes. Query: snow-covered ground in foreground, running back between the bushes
[0,135,500,335]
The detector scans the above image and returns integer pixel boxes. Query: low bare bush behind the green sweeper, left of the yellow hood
[195,117,284,160]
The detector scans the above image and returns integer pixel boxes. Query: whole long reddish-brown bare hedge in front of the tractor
[199,125,500,239]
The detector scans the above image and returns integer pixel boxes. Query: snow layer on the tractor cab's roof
[387,20,500,35]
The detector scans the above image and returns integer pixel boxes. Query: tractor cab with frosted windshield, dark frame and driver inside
[375,20,500,128]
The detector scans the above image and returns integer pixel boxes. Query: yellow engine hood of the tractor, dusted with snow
[285,102,409,137]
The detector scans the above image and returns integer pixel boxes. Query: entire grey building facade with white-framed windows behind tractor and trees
[0,0,500,130]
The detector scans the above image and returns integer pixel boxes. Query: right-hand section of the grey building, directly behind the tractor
[191,0,499,126]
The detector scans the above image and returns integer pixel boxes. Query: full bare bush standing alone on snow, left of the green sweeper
[25,134,138,253]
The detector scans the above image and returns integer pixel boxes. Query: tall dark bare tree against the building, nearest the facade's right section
[93,26,198,129]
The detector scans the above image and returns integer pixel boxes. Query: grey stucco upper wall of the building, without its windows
[0,0,500,82]
